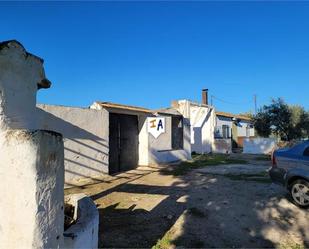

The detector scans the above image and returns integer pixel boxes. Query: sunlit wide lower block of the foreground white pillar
[0,130,64,249]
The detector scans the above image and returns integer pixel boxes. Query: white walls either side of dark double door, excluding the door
[37,103,191,187]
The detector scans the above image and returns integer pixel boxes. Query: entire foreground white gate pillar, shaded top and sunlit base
[0,41,64,249]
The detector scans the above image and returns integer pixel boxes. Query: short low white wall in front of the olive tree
[243,138,276,154]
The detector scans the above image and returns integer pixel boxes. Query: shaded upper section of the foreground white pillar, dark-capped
[0,42,45,129]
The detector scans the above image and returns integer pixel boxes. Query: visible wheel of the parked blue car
[290,180,309,207]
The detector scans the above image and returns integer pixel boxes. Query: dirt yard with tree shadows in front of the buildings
[66,155,309,248]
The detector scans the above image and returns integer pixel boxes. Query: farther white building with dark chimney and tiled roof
[172,89,255,154]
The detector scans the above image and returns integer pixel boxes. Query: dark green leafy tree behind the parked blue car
[253,98,309,141]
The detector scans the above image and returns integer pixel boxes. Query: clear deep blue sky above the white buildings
[0,2,309,113]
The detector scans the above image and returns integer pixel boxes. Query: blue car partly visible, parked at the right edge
[269,141,309,207]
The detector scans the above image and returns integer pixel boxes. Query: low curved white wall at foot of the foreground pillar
[64,194,99,249]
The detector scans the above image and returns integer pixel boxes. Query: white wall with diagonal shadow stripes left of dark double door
[38,105,109,187]
